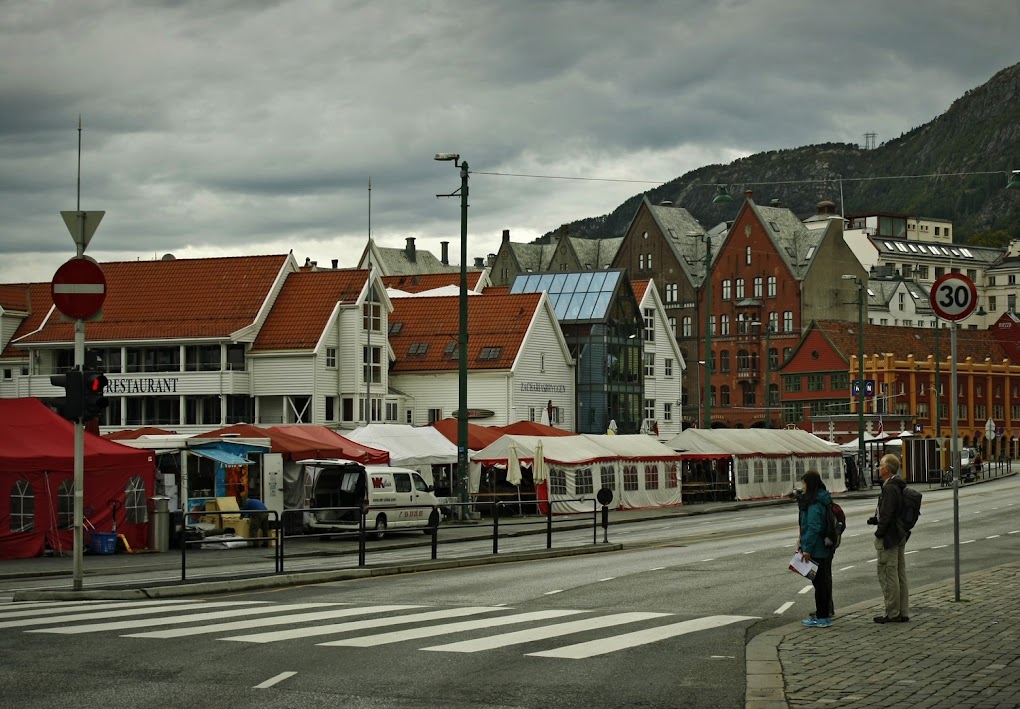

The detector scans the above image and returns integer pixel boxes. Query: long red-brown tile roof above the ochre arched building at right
[815,320,1008,362]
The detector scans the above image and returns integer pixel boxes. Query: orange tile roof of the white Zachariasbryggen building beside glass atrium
[390,293,543,371]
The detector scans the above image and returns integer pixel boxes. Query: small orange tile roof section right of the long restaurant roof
[252,269,368,352]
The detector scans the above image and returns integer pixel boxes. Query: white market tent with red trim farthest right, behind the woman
[666,428,847,500]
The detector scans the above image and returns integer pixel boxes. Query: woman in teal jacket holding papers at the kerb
[797,470,833,627]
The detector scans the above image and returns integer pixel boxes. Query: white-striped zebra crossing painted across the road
[0,600,758,660]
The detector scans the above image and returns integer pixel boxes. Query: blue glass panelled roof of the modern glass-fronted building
[510,270,621,322]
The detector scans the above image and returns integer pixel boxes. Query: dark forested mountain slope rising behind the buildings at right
[543,63,1020,246]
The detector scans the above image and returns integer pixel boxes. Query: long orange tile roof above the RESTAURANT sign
[13,254,295,346]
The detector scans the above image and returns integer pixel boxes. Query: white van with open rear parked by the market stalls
[300,459,441,539]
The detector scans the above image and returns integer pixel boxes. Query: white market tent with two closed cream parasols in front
[471,434,680,512]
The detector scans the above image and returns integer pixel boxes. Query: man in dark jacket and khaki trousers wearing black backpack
[868,453,910,623]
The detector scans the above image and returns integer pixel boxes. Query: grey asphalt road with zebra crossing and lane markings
[0,477,1020,709]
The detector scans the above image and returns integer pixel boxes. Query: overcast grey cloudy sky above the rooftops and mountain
[0,0,1020,283]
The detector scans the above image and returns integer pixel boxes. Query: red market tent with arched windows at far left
[0,399,155,559]
